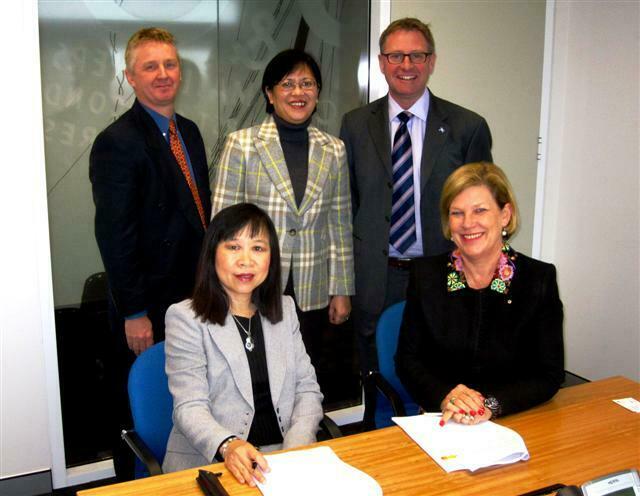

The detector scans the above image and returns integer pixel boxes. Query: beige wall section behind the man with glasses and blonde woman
[391,0,545,254]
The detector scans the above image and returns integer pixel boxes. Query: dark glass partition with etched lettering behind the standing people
[39,0,369,465]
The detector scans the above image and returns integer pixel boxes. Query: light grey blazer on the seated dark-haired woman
[162,296,323,472]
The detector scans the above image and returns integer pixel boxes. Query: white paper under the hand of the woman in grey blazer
[258,446,382,496]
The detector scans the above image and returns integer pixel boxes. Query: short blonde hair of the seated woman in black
[440,162,520,239]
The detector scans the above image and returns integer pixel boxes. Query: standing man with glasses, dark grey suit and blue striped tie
[340,18,492,384]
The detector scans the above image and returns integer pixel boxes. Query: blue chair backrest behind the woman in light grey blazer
[129,341,173,476]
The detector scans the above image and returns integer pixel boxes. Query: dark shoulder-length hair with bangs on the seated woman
[191,203,282,325]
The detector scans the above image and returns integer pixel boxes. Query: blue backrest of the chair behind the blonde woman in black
[375,301,418,428]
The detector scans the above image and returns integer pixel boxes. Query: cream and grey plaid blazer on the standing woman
[211,116,354,312]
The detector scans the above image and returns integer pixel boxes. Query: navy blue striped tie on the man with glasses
[389,112,417,253]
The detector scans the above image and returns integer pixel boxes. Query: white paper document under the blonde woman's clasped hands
[393,414,529,473]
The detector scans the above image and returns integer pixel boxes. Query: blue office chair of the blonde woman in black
[364,301,419,429]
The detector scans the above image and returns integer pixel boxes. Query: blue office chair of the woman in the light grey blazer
[122,341,342,479]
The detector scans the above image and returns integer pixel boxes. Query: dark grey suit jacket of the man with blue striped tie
[340,93,493,315]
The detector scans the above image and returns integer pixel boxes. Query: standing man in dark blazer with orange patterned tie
[89,28,211,479]
